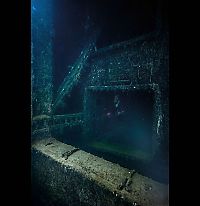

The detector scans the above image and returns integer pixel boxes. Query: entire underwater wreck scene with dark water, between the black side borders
[31,0,169,206]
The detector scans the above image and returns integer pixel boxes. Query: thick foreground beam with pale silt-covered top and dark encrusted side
[32,138,169,206]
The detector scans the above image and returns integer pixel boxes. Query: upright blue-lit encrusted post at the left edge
[31,0,54,116]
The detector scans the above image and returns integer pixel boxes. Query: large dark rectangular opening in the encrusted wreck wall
[84,85,160,165]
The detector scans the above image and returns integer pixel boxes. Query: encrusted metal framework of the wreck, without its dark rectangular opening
[31,0,169,203]
